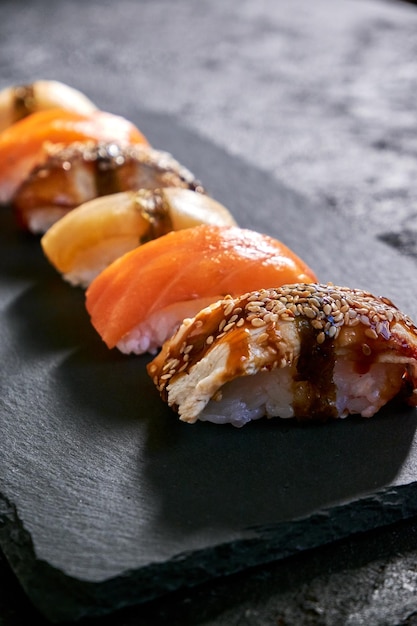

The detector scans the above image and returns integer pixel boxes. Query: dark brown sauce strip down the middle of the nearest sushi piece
[293,318,337,420]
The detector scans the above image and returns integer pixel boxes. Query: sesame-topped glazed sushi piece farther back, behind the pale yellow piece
[12,141,203,234]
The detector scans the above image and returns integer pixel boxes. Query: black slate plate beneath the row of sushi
[0,112,417,622]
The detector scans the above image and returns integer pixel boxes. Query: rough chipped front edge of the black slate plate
[0,482,417,623]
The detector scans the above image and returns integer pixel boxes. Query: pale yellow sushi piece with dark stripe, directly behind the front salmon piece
[41,187,236,287]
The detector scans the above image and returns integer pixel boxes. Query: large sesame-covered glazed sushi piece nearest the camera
[148,284,417,426]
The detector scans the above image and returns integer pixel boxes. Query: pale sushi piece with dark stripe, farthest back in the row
[0,80,97,132]
